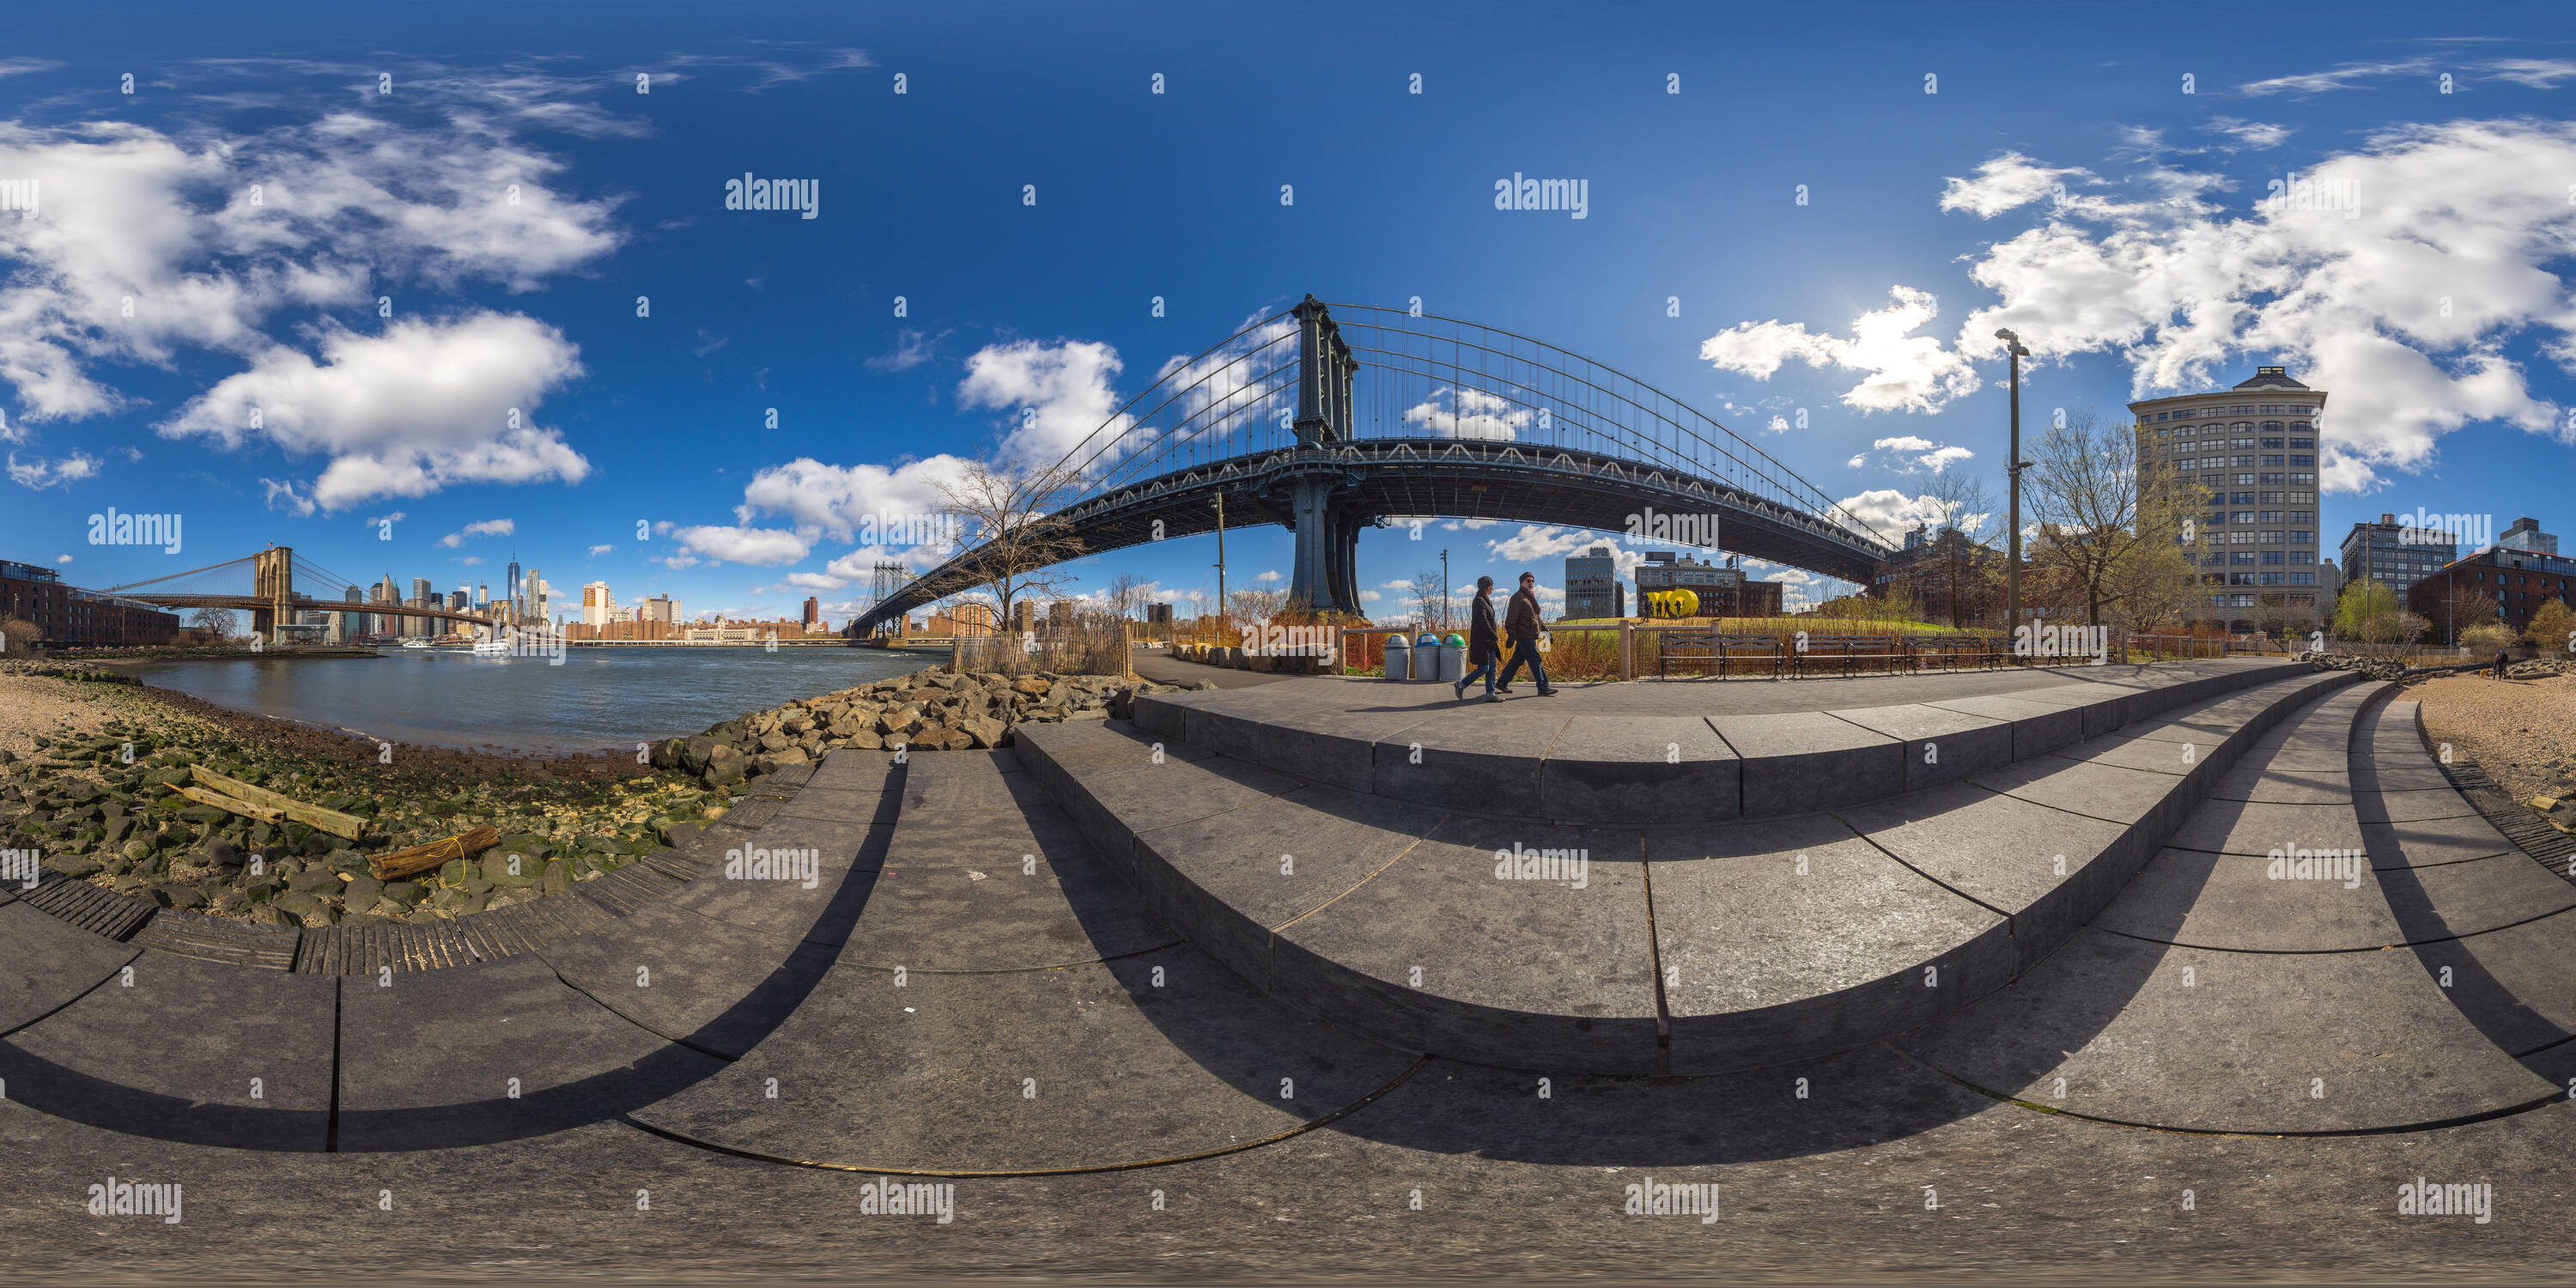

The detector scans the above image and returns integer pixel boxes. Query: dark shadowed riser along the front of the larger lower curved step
[1020,672,2360,1074]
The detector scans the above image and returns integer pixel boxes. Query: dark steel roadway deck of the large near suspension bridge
[858,438,1880,631]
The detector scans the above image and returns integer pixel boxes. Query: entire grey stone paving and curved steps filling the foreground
[0,662,2576,1278]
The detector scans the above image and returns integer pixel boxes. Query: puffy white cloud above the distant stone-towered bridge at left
[158,312,590,510]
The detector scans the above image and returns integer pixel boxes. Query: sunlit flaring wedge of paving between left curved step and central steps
[634,747,1414,1175]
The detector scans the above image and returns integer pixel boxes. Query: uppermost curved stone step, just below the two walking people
[1136,659,2308,824]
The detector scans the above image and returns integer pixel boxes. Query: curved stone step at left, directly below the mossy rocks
[0,752,904,1151]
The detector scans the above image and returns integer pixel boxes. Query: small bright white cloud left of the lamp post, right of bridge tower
[1700,286,1978,412]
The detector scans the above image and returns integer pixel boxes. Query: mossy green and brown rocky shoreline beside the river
[0,662,1177,927]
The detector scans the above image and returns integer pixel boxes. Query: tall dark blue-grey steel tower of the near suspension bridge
[1288,294,1373,613]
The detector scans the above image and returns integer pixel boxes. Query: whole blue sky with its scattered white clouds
[0,3,2576,616]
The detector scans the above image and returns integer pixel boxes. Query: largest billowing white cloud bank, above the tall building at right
[1710,121,2576,492]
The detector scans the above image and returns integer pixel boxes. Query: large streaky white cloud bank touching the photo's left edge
[0,111,621,422]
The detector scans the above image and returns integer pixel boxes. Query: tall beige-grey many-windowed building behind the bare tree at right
[2128,366,2357,629]
